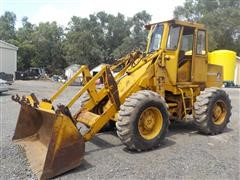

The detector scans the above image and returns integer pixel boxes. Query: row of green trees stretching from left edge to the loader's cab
[0,11,151,73]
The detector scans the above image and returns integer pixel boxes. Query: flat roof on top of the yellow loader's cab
[145,19,206,30]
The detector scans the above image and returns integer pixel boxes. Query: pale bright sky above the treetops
[0,0,184,28]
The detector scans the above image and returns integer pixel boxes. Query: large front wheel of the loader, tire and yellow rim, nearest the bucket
[116,90,169,151]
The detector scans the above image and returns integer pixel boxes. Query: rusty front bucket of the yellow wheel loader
[13,104,85,179]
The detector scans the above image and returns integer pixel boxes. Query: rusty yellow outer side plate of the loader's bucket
[42,112,85,179]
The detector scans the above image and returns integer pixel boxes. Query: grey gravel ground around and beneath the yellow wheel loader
[0,81,240,180]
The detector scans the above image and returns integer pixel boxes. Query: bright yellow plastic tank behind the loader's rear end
[208,50,237,81]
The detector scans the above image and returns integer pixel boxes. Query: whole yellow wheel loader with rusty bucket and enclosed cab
[13,20,231,179]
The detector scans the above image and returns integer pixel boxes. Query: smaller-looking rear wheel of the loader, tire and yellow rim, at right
[194,88,232,135]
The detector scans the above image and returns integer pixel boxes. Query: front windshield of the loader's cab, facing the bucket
[148,24,163,52]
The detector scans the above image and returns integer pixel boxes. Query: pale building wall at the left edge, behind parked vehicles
[0,40,18,76]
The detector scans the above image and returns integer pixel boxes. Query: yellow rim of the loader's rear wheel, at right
[212,100,227,125]
